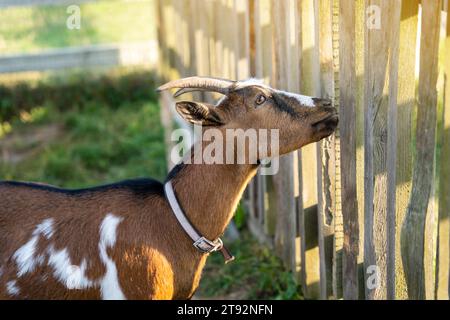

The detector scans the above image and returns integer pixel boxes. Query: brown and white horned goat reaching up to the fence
[0,77,338,299]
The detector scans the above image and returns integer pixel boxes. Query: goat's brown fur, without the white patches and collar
[0,80,337,299]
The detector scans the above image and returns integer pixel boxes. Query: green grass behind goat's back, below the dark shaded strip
[0,102,166,187]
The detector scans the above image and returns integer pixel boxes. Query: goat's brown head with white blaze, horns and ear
[158,77,338,159]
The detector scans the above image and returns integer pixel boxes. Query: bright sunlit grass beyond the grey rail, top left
[0,0,156,54]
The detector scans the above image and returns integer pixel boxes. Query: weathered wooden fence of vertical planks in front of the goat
[155,0,450,299]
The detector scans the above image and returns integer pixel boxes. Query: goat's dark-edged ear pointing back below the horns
[176,101,223,126]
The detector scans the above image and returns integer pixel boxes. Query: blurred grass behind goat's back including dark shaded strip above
[0,69,166,187]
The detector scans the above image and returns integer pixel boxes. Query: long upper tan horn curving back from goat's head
[157,77,236,97]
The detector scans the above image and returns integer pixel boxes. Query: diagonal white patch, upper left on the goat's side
[13,219,53,277]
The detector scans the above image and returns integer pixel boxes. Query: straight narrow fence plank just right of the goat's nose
[339,1,359,300]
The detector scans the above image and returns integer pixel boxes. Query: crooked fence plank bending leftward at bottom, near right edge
[401,1,441,299]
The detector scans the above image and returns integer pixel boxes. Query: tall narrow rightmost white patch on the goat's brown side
[98,214,125,300]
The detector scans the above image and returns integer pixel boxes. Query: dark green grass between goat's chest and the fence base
[196,231,301,299]
